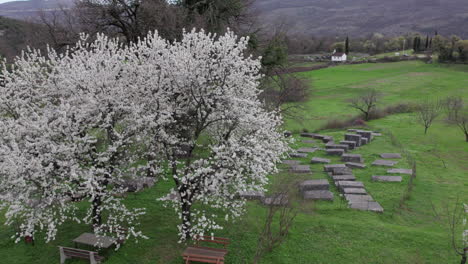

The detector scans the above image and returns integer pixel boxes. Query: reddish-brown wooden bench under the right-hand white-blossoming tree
[182,236,230,264]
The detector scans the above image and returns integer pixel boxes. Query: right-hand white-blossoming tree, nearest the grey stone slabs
[130,31,287,240]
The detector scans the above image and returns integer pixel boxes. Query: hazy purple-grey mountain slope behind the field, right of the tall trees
[254,0,468,37]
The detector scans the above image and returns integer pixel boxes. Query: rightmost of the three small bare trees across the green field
[444,97,468,142]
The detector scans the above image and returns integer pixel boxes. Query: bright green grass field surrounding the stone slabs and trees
[0,61,468,264]
